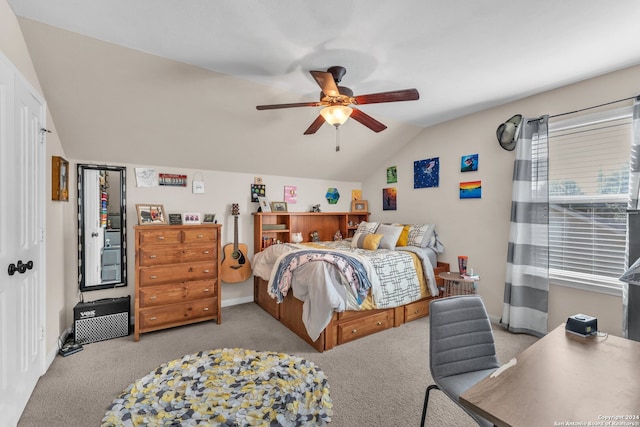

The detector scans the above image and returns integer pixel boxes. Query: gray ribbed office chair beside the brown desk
[420,295,500,427]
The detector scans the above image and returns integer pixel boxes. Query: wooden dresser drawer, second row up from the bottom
[140,280,216,307]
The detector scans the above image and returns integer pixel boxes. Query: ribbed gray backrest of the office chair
[429,295,500,380]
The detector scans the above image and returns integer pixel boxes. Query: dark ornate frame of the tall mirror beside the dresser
[77,163,127,292]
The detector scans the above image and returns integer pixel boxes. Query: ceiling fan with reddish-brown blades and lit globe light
[256,66,420,135]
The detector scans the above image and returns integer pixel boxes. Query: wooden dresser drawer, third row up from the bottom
[139,261,217,286]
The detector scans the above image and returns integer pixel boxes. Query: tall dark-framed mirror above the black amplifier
[78,164,127,291]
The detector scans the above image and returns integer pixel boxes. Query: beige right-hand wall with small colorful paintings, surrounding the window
[362,66,640,335]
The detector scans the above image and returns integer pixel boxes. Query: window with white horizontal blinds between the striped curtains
[549,107,631,294]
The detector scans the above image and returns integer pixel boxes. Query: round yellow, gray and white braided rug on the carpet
[102,348,333,427]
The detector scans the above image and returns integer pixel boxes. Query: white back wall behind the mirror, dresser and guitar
[70,160,361,325]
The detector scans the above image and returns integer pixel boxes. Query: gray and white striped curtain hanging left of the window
[500,116,549,337]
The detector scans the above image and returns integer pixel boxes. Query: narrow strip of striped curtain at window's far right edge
[621,96,640,338]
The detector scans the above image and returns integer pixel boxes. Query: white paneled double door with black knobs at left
[0,56,46,426]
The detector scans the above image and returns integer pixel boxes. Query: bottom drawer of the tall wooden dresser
[139,298,217,331]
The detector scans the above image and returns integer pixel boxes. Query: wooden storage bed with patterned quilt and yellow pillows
[252,222,449,351]
